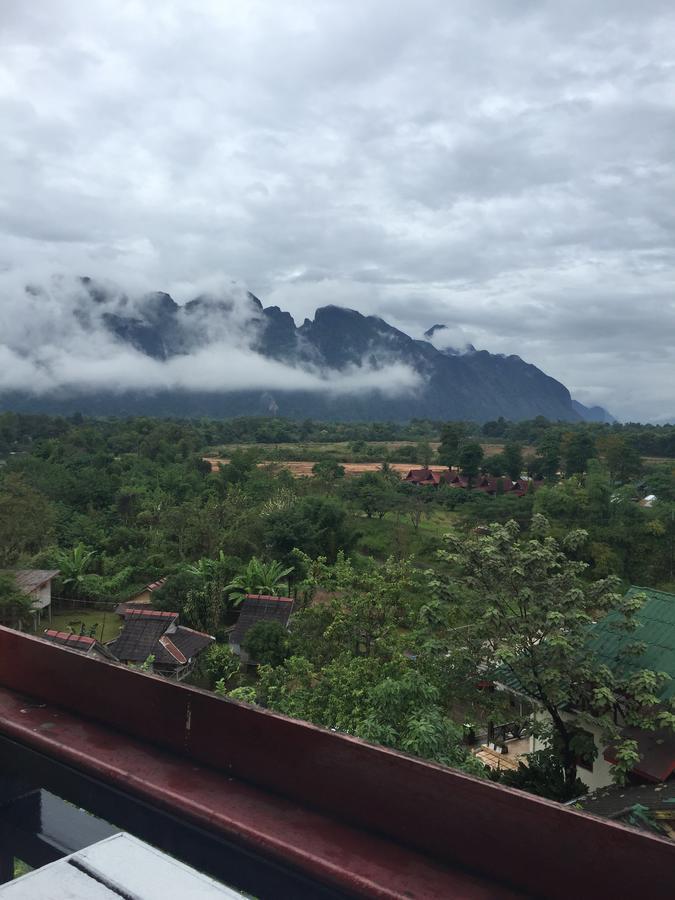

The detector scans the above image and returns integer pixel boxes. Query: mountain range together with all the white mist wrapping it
[0,278,608,421]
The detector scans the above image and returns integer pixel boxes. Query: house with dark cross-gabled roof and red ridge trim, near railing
[106,609,215,681]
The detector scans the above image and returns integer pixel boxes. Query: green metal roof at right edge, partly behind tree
[591,587,675,701]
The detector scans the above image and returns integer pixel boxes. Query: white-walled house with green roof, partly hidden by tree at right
[499,586,675,790]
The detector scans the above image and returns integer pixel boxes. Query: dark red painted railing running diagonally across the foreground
[0,628,675,900]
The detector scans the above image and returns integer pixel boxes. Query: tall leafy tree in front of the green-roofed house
[441,515,675,788]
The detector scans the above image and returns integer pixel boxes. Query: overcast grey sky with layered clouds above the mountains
[0,0,675,421]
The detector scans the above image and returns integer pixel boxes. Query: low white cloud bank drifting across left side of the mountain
[0,273,421,396]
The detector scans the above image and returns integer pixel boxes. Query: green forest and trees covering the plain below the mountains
[0,412,675,799]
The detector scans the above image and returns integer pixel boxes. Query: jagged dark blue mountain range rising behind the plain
[0,278,611,422]
